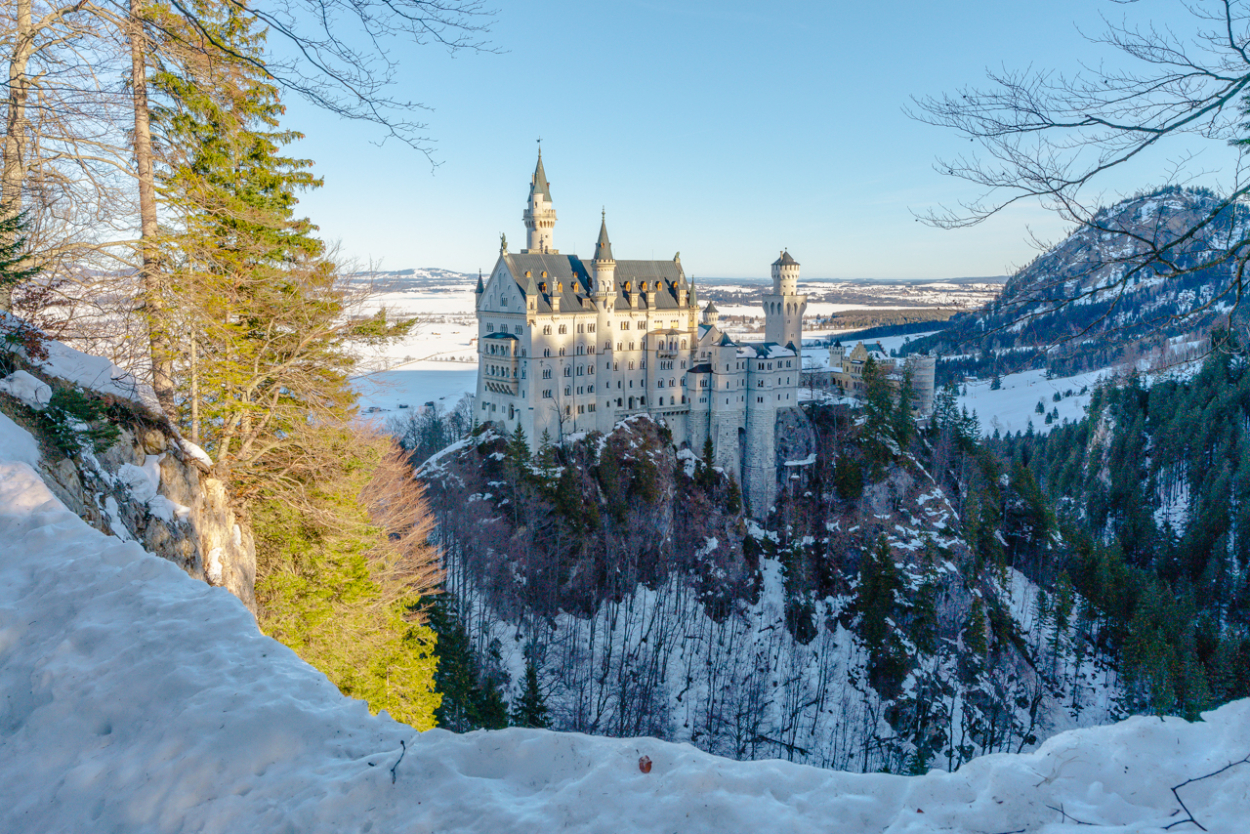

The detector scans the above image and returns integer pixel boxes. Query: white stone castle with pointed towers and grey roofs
[475,150,808,518]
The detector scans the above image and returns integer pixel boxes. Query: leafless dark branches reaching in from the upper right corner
[911,0,1250,338]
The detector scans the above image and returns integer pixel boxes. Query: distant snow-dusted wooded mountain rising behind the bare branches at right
[905,186,1246,381]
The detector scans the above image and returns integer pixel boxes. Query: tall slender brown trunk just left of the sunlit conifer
[130,0,174,418]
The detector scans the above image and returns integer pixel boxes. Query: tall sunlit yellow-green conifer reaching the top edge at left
[151,3,406,478]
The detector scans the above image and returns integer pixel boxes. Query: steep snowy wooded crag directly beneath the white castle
[419,367,1135,771]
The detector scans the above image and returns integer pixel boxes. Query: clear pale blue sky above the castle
[286,0,1225,279]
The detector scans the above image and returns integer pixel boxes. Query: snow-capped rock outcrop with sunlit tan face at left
[0,327,256,613]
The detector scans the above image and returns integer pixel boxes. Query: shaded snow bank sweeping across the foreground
[0,415,1250,834]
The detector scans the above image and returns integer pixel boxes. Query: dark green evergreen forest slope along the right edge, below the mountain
[996,334,1250,715]
